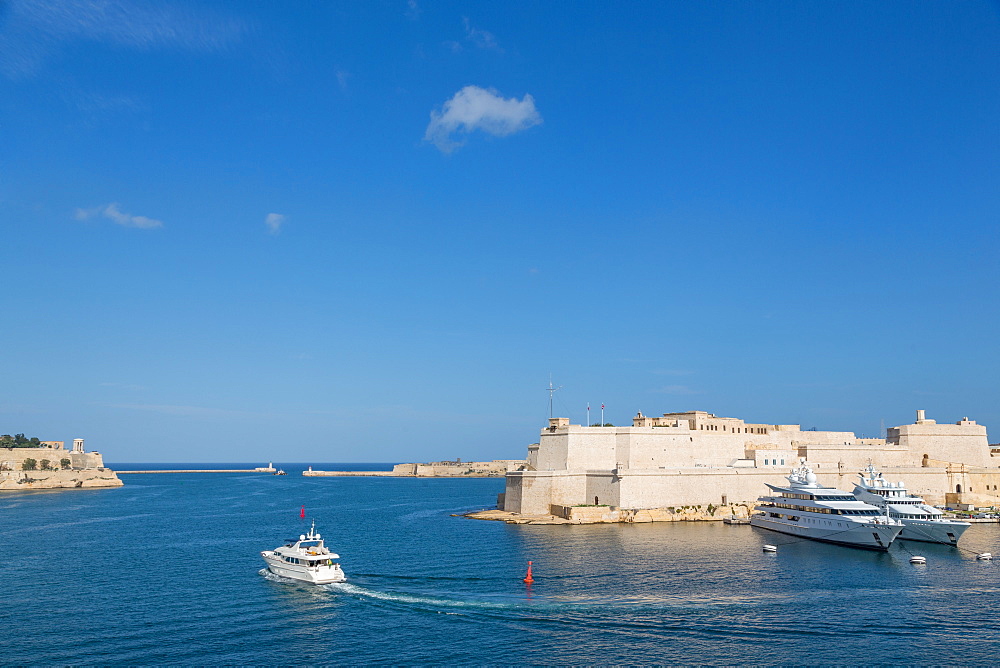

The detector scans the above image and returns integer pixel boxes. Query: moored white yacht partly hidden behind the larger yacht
[854,463,972,545]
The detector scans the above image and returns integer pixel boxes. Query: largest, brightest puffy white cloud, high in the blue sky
[424,86,542,153]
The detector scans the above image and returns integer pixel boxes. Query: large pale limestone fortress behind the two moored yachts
[497,410,1000,522]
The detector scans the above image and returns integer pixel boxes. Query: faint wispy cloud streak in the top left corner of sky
[0,0,248,78]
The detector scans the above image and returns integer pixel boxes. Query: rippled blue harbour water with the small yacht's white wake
[0,464,1000,665]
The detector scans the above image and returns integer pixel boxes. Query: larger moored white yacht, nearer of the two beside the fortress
[750,464,903,550]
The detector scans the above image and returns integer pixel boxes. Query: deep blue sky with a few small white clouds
[0,0,1000,462]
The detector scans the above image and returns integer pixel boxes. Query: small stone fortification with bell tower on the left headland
[0,438,122,491]
